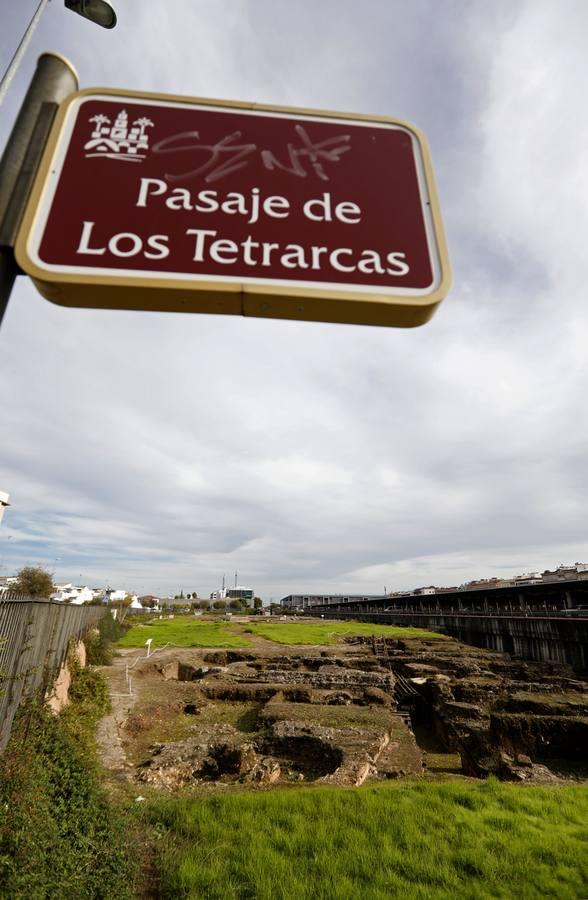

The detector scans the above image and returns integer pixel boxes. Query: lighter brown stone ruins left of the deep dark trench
[139,651,423,788]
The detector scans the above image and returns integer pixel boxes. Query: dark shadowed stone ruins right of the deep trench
[368,640,588,781]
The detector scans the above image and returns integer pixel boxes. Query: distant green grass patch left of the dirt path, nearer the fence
[117,616,249,651]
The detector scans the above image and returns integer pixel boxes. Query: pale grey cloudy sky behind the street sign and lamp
[0,0,588,600]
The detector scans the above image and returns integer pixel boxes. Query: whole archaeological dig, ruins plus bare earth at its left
[99,624,588,791]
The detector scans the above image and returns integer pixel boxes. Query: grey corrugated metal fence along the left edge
[0,594,106,751]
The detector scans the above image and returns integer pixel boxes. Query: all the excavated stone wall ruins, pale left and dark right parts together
[130,638,588,789]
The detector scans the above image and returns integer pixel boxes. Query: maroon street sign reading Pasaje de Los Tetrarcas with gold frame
[16,89,450,326]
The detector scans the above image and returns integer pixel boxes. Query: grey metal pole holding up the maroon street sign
[0,53,78,324]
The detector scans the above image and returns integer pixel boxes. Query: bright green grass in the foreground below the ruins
[138,780,588,900]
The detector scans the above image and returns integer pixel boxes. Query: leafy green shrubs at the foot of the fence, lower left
[0,667,137,900]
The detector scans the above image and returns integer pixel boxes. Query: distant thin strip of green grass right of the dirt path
[245,622,447,644]
